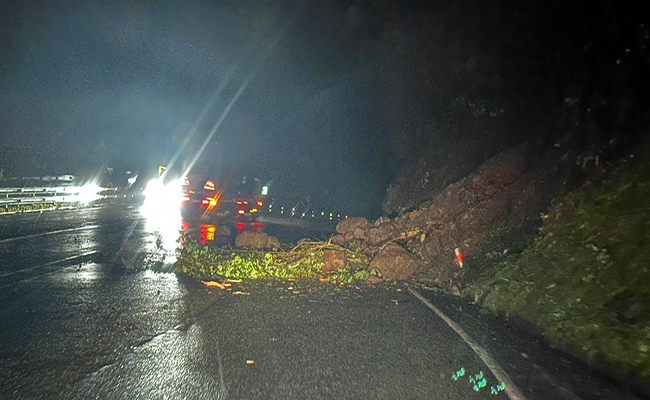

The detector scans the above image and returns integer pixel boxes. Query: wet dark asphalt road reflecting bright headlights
[0,206,635,400]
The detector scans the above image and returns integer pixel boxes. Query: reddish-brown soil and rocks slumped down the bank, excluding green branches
[332,145,584,287]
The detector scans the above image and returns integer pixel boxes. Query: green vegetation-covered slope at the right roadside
[466,150,650,378]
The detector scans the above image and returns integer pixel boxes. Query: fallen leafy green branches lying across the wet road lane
[175,240,371,284]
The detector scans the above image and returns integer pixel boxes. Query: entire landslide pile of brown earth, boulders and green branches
[173,145,604,290]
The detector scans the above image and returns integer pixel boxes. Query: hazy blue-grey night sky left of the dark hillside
[0,2,390,214]
